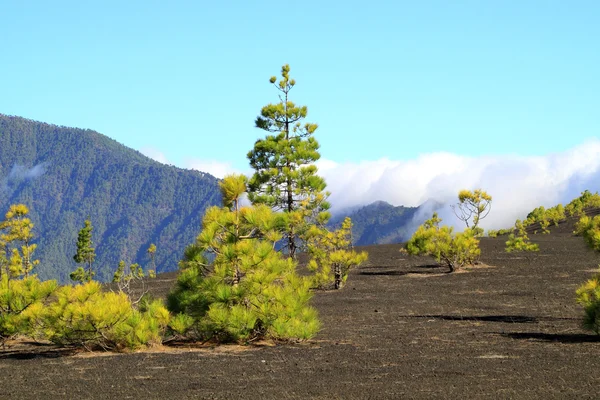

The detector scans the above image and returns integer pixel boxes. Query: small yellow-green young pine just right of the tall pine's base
[306,218,368,289]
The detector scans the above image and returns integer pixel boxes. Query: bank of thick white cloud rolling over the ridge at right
[317,139,600,229]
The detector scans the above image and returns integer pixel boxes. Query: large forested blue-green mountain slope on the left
[0,114,220,281]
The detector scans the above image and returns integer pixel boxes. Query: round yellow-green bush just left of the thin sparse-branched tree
[406,213,481,272]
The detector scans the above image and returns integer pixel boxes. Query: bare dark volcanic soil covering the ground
[0,219,600,399]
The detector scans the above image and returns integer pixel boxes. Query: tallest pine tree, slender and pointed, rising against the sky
[248,65,329,258]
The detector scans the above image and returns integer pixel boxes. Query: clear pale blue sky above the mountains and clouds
[0,0,600,169]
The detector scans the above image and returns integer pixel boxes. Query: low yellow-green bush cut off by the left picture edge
[0,274,57,341]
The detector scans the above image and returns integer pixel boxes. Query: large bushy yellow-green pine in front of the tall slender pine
[168,175,319,341]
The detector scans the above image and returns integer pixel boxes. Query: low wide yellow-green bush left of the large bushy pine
[43,281,169,350]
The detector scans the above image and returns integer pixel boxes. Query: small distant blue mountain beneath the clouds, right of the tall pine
[330,201,422,246]
